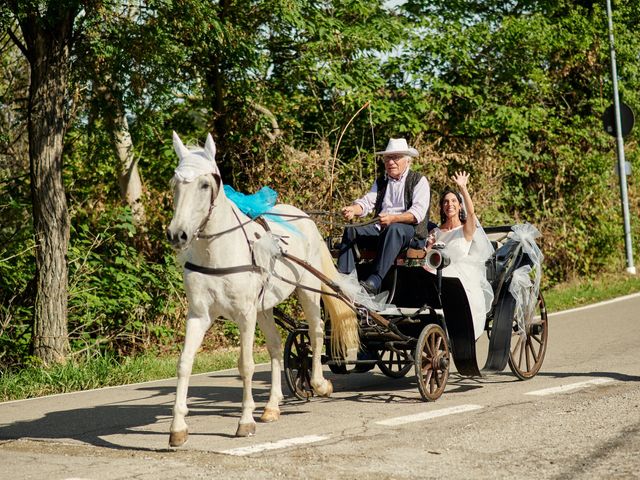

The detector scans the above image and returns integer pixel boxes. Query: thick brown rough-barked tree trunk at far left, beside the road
[21,12,75,365]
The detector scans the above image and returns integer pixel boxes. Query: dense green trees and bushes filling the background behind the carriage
[0,0,640,372]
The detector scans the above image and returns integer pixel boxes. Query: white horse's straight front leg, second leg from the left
[236,310,257,437]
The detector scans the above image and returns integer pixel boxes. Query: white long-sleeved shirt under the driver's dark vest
[353,167,431,223]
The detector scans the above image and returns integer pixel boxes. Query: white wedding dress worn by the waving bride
[433,226,493,340]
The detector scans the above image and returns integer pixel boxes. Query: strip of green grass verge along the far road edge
[0,273,640,402]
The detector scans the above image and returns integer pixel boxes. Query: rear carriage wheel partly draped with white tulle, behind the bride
[509,293,549,380]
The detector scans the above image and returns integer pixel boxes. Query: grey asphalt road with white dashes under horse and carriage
[0,294,640,480]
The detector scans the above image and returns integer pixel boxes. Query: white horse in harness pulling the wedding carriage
[167,132,358,447]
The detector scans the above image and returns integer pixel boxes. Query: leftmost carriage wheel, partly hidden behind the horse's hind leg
[284,330,313,400]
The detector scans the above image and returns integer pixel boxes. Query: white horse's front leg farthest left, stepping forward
[169,316,211,447]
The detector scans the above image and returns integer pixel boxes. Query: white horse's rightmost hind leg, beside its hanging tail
[298,288,333,397]
